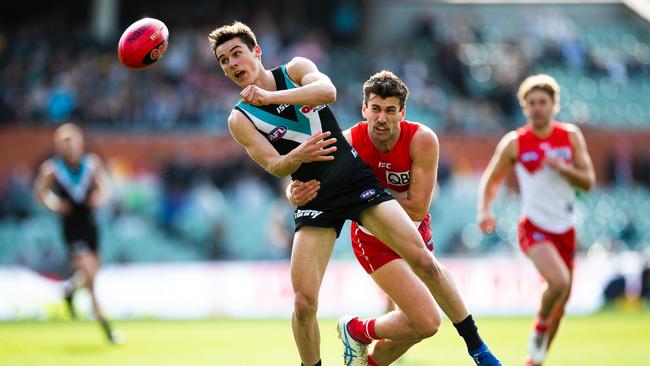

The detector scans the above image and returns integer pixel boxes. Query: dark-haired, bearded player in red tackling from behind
[287,71,499,366]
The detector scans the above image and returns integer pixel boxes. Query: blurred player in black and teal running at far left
[34,123,122,344]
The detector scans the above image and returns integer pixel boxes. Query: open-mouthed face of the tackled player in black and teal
[217,38,262,88]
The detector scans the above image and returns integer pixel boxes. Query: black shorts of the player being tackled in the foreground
[293,182,393,238]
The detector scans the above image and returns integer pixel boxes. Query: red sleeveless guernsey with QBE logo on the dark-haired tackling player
[351,121,430,234]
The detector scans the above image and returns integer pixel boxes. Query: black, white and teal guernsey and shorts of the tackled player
[235,65,392,237]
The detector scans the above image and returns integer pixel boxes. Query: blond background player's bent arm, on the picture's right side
[545,125,596,191]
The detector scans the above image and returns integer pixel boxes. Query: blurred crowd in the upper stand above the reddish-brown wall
[0,0,650,134]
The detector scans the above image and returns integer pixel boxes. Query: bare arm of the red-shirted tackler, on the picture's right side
[395,126,440,221]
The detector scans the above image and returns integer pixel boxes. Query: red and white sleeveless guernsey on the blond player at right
[515,122,576,233]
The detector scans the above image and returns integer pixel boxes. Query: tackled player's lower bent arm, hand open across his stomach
[228,110,336,177]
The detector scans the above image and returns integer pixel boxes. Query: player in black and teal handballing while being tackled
[209,22,494,366]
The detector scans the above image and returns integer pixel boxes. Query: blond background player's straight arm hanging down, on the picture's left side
[476,132,519,234]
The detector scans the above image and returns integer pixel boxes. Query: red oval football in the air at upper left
[117,18,169,69]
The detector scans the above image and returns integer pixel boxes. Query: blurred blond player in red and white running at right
[477,74,595,365]
